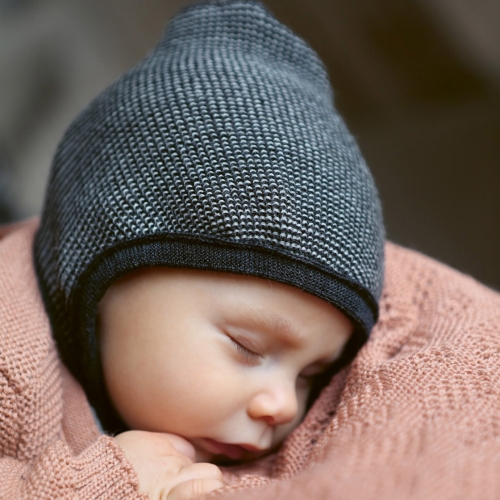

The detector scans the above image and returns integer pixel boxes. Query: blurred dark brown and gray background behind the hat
[0,0,500,290]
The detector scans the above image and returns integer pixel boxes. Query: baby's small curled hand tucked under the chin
[114,431,222,500]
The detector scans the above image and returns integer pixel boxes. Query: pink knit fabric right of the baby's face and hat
[221,244,500,500]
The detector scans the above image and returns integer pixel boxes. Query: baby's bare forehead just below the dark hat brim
[110,266,352,350]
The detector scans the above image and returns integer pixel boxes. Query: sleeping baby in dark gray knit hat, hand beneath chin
[3,0,384,500]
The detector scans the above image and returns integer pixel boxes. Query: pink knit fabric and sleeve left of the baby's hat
[0,221,147,500]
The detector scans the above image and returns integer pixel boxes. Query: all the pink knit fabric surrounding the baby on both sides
[0,221,500,500]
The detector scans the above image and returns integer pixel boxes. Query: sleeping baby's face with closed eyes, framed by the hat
[99,268,352,463]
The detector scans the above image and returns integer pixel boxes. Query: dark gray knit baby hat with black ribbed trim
[35,0,384,429]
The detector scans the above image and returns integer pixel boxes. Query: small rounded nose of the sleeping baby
[247,383,298,425]
